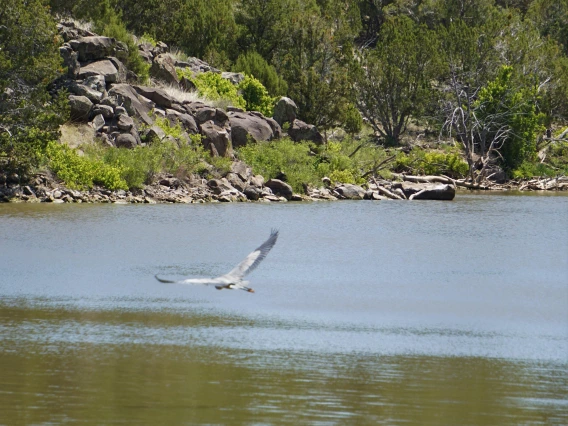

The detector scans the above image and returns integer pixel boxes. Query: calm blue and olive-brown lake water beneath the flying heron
[0,193,568,425]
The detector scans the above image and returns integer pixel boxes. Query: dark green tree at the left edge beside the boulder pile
[0,0,68,178]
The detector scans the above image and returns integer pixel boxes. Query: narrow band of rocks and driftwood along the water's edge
[0,162,568,204]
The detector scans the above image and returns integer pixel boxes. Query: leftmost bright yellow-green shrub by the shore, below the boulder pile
[46,142,128,190]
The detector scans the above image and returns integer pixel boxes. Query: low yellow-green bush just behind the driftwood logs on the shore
[394,148,469,179]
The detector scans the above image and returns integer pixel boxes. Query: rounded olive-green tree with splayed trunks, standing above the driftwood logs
[353,17,439,144]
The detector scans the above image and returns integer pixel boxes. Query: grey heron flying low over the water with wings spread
[155,229,278,293]
